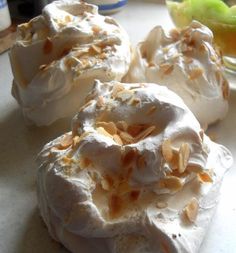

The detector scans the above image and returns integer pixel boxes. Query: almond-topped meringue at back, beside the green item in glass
[124,21,229,129]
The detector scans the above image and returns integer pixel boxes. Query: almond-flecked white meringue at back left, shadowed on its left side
[10,0,131,126]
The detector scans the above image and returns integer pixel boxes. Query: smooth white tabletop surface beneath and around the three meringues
[0,0,236,253]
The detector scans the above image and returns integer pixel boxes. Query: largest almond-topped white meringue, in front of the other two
[37,81,232,253]
